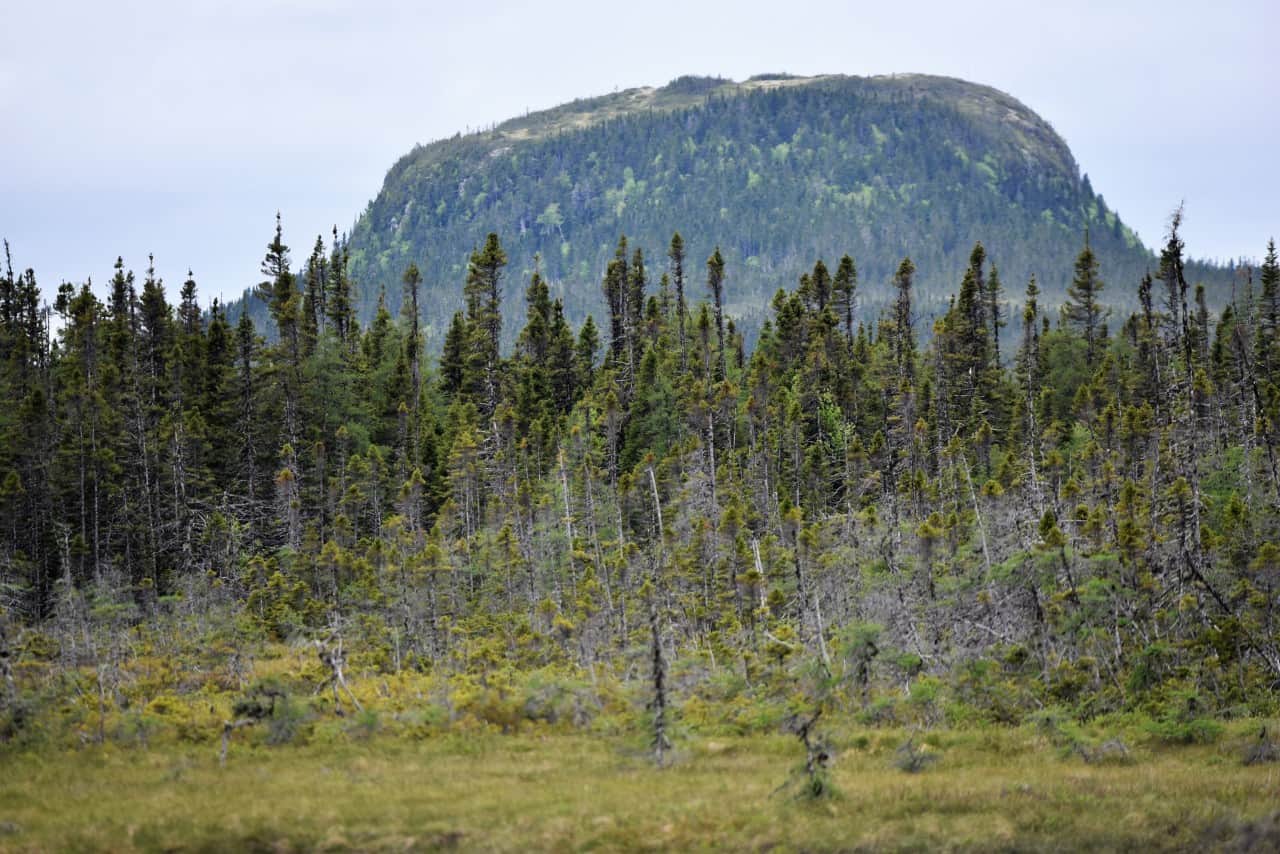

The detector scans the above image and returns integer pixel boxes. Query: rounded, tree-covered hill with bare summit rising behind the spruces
[351,76,1229,346]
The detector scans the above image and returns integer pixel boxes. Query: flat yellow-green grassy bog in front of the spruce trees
[0,730,1280,851]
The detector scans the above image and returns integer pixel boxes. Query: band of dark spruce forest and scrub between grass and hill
[0,209,1280,753]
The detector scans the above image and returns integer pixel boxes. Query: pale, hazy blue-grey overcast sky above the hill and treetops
[0,0,1280,300]
